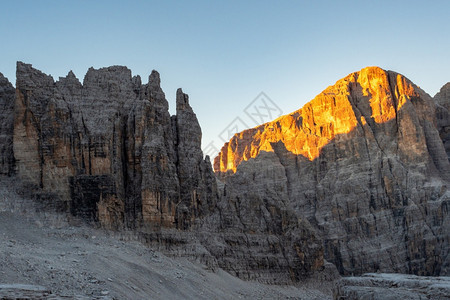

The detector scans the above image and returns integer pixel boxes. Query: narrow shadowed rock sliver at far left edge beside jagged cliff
[0,73,15,175]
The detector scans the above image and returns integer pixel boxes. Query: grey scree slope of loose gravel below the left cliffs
[0,177,334,300]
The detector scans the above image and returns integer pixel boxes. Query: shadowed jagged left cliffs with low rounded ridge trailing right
[0,62,324,283]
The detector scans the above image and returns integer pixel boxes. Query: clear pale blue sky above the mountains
[0,0,450,156]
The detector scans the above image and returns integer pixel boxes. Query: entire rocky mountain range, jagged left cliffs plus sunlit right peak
[0,62,450,283]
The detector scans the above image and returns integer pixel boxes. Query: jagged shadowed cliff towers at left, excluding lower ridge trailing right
[14,62,217,229]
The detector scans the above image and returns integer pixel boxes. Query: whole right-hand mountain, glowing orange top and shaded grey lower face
[214,67,450,275]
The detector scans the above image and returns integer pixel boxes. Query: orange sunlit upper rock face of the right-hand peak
[214,67,426,172]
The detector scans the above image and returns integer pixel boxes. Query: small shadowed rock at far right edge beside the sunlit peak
[434,82,450,160]
